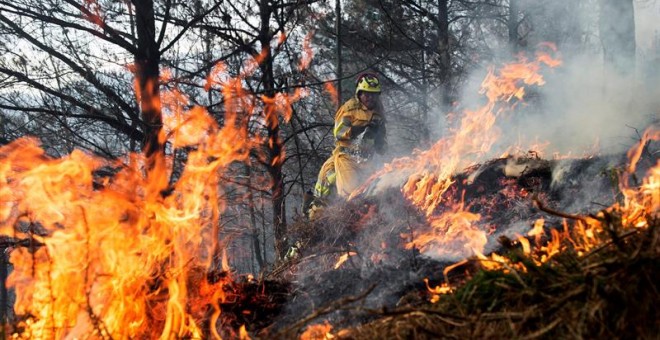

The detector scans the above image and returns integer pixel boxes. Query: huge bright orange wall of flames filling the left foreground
[0,43,304,339]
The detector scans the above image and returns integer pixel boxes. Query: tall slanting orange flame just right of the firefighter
[351,45,561,257]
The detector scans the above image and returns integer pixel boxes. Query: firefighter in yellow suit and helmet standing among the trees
[308,73,387,218]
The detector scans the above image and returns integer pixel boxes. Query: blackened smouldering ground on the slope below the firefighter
[253,149,657,337]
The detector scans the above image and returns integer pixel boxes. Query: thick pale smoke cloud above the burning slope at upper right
[438,0,660,158]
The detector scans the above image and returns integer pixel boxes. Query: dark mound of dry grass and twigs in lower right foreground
[338,206,660,339]
